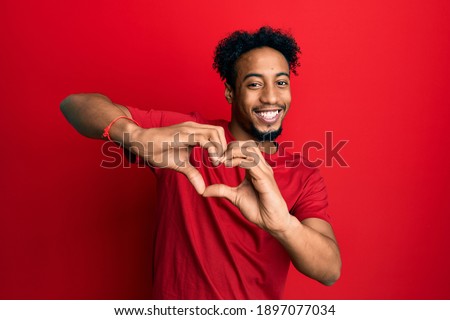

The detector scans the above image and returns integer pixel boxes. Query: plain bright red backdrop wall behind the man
[0,0,450,299]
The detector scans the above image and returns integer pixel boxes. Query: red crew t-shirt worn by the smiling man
[128,107,330,299]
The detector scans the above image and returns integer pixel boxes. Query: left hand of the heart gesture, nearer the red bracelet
[129,121,227,194]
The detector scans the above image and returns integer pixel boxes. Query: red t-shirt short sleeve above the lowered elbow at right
[291,169,331,223]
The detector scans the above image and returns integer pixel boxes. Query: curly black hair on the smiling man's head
[213,26,301,89]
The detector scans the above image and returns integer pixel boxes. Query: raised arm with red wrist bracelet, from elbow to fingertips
[61,94,226,194]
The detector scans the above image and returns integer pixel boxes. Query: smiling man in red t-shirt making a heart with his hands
[61,27,341,299]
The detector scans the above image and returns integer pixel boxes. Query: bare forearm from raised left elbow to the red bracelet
[61,94,132,139]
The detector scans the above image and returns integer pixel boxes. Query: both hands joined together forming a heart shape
[130,122,290,232]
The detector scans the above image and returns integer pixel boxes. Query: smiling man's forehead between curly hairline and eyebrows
[236,47,289,78]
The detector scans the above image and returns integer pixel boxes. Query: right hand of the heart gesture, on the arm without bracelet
[203,141,291,233]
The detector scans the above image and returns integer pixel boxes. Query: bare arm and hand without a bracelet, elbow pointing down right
[203,141,341,285]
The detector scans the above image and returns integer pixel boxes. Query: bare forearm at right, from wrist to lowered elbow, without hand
[274,216,341,285]
